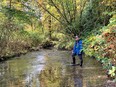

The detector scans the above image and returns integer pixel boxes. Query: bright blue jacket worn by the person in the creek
[73,39,83,54]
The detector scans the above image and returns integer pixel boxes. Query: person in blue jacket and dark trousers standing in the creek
[72,36,83,67]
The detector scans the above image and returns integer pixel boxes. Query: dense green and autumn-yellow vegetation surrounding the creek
[0,0,116,78]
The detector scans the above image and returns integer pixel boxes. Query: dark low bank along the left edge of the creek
[0,40,55,62]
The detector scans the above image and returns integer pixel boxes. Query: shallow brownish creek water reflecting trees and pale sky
[0,49,106,87]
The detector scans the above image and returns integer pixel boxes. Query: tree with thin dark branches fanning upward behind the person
[37,0,86,35]
